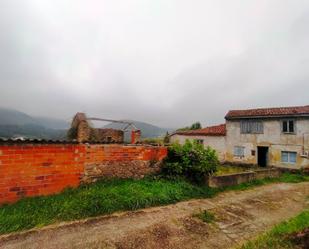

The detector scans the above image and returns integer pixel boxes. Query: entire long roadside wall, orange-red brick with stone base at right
[0,144,166,204]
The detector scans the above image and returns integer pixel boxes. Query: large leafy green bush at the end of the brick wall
[162,140,219,182]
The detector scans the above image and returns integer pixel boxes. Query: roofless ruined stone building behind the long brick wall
[68,112,141,144]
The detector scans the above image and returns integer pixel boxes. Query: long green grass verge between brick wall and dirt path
[0,174,309,234]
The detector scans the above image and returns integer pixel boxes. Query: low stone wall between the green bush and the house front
[206,168,281,188]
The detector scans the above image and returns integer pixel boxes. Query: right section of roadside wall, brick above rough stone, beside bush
[82,145,167,182]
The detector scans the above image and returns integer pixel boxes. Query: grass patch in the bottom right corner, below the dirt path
[241,210,309,249]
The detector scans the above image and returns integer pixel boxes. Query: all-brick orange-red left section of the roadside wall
[0,144,85,203]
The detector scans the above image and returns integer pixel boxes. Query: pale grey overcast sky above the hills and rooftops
[0,0,309,127]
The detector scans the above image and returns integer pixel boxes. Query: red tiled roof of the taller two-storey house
[225,105,309,119]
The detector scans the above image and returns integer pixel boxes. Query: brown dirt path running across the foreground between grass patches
[0,183,309,249]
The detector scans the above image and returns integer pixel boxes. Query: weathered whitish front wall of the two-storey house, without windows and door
[225,119,309,168]
